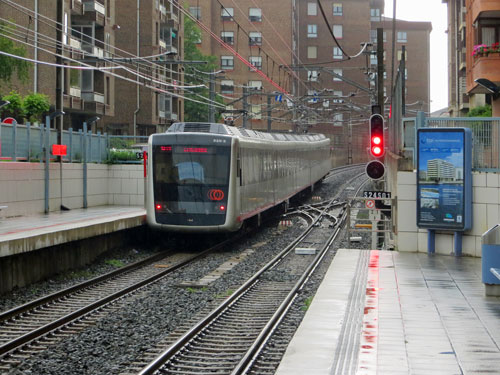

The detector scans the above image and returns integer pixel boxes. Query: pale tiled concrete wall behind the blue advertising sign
[396,172,500,257]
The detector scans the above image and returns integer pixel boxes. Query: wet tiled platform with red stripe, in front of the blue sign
[276,249,500,375]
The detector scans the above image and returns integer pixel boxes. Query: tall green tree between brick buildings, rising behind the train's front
[184,17,223,122]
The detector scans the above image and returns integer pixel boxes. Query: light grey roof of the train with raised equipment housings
[167,122,326,142]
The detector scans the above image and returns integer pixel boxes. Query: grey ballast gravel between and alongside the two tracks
[4,168,376,375]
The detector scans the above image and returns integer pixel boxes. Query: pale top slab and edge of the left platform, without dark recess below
[0,206,146,258]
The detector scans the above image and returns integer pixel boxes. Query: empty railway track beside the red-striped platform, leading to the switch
[133,175,361,375]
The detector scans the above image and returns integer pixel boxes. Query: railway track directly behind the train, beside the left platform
[0,233,243,371]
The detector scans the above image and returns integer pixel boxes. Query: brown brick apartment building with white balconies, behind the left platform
[0,0,183,135]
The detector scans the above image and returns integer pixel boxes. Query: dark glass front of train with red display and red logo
[153,145,231,220]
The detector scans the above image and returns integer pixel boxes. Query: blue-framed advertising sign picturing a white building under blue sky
[417,128,472,231]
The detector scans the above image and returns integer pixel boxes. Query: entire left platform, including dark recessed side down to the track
[0,206,146,293]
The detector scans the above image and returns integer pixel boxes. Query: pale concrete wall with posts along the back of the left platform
[0,162,144,217]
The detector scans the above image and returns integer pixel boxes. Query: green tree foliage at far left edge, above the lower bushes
[0,23,30,83]
